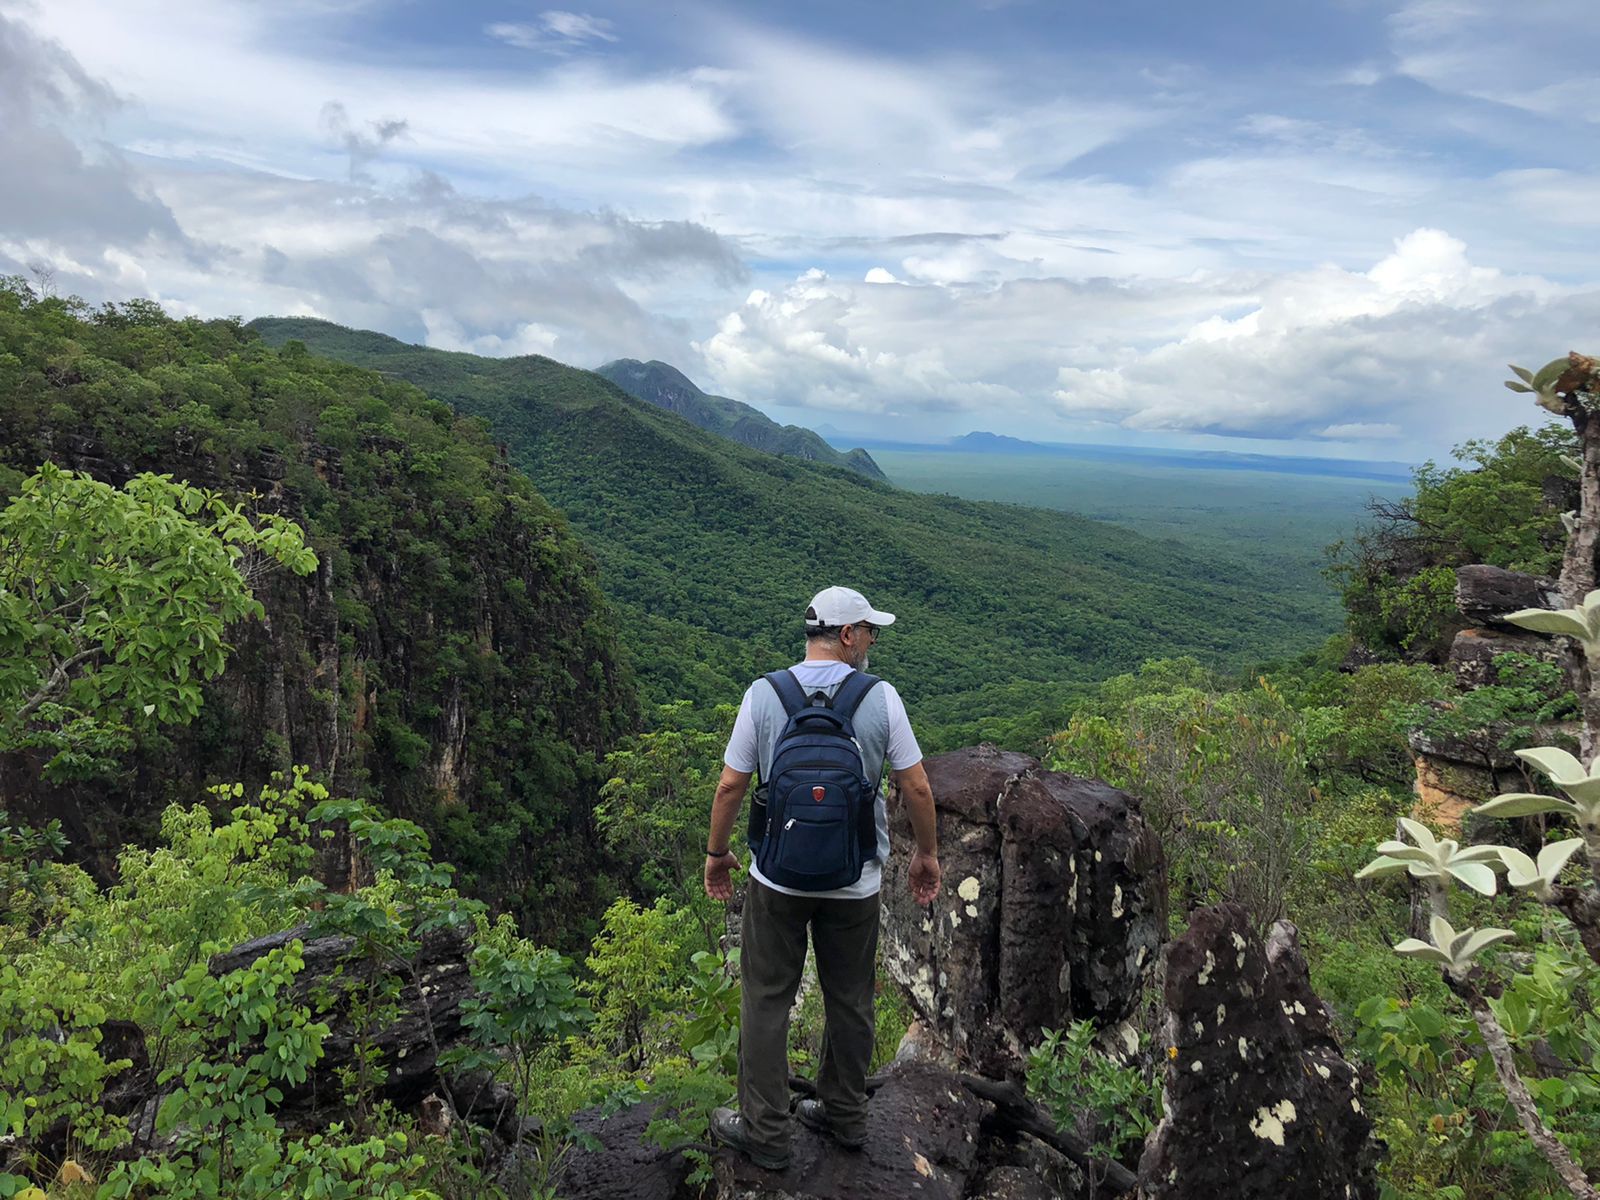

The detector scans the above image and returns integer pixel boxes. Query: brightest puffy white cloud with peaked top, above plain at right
[1054,229,1600,442]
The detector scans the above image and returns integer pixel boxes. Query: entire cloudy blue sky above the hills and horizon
[0,0,1600,461]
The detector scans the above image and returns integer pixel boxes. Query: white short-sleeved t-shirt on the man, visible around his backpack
[723,659,922,899]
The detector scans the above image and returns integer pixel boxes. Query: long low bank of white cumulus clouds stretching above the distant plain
[698,229,1600,453]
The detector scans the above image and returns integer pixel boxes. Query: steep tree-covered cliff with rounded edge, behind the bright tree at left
[0,285,635,936]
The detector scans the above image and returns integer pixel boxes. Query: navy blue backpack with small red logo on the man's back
[750,670,878,891]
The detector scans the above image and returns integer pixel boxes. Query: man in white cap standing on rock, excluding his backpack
[706,587,939,1171]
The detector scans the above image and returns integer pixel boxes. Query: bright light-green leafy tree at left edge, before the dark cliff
[0,464,317,773]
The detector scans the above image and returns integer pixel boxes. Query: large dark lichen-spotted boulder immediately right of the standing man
[883,747,1165,1077]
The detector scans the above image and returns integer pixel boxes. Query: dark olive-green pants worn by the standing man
[739,878,878,1152]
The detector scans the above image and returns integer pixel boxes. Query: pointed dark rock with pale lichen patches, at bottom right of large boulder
[1139,904,1378,1200]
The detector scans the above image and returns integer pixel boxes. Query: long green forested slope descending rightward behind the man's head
[251,320,1331,746]
